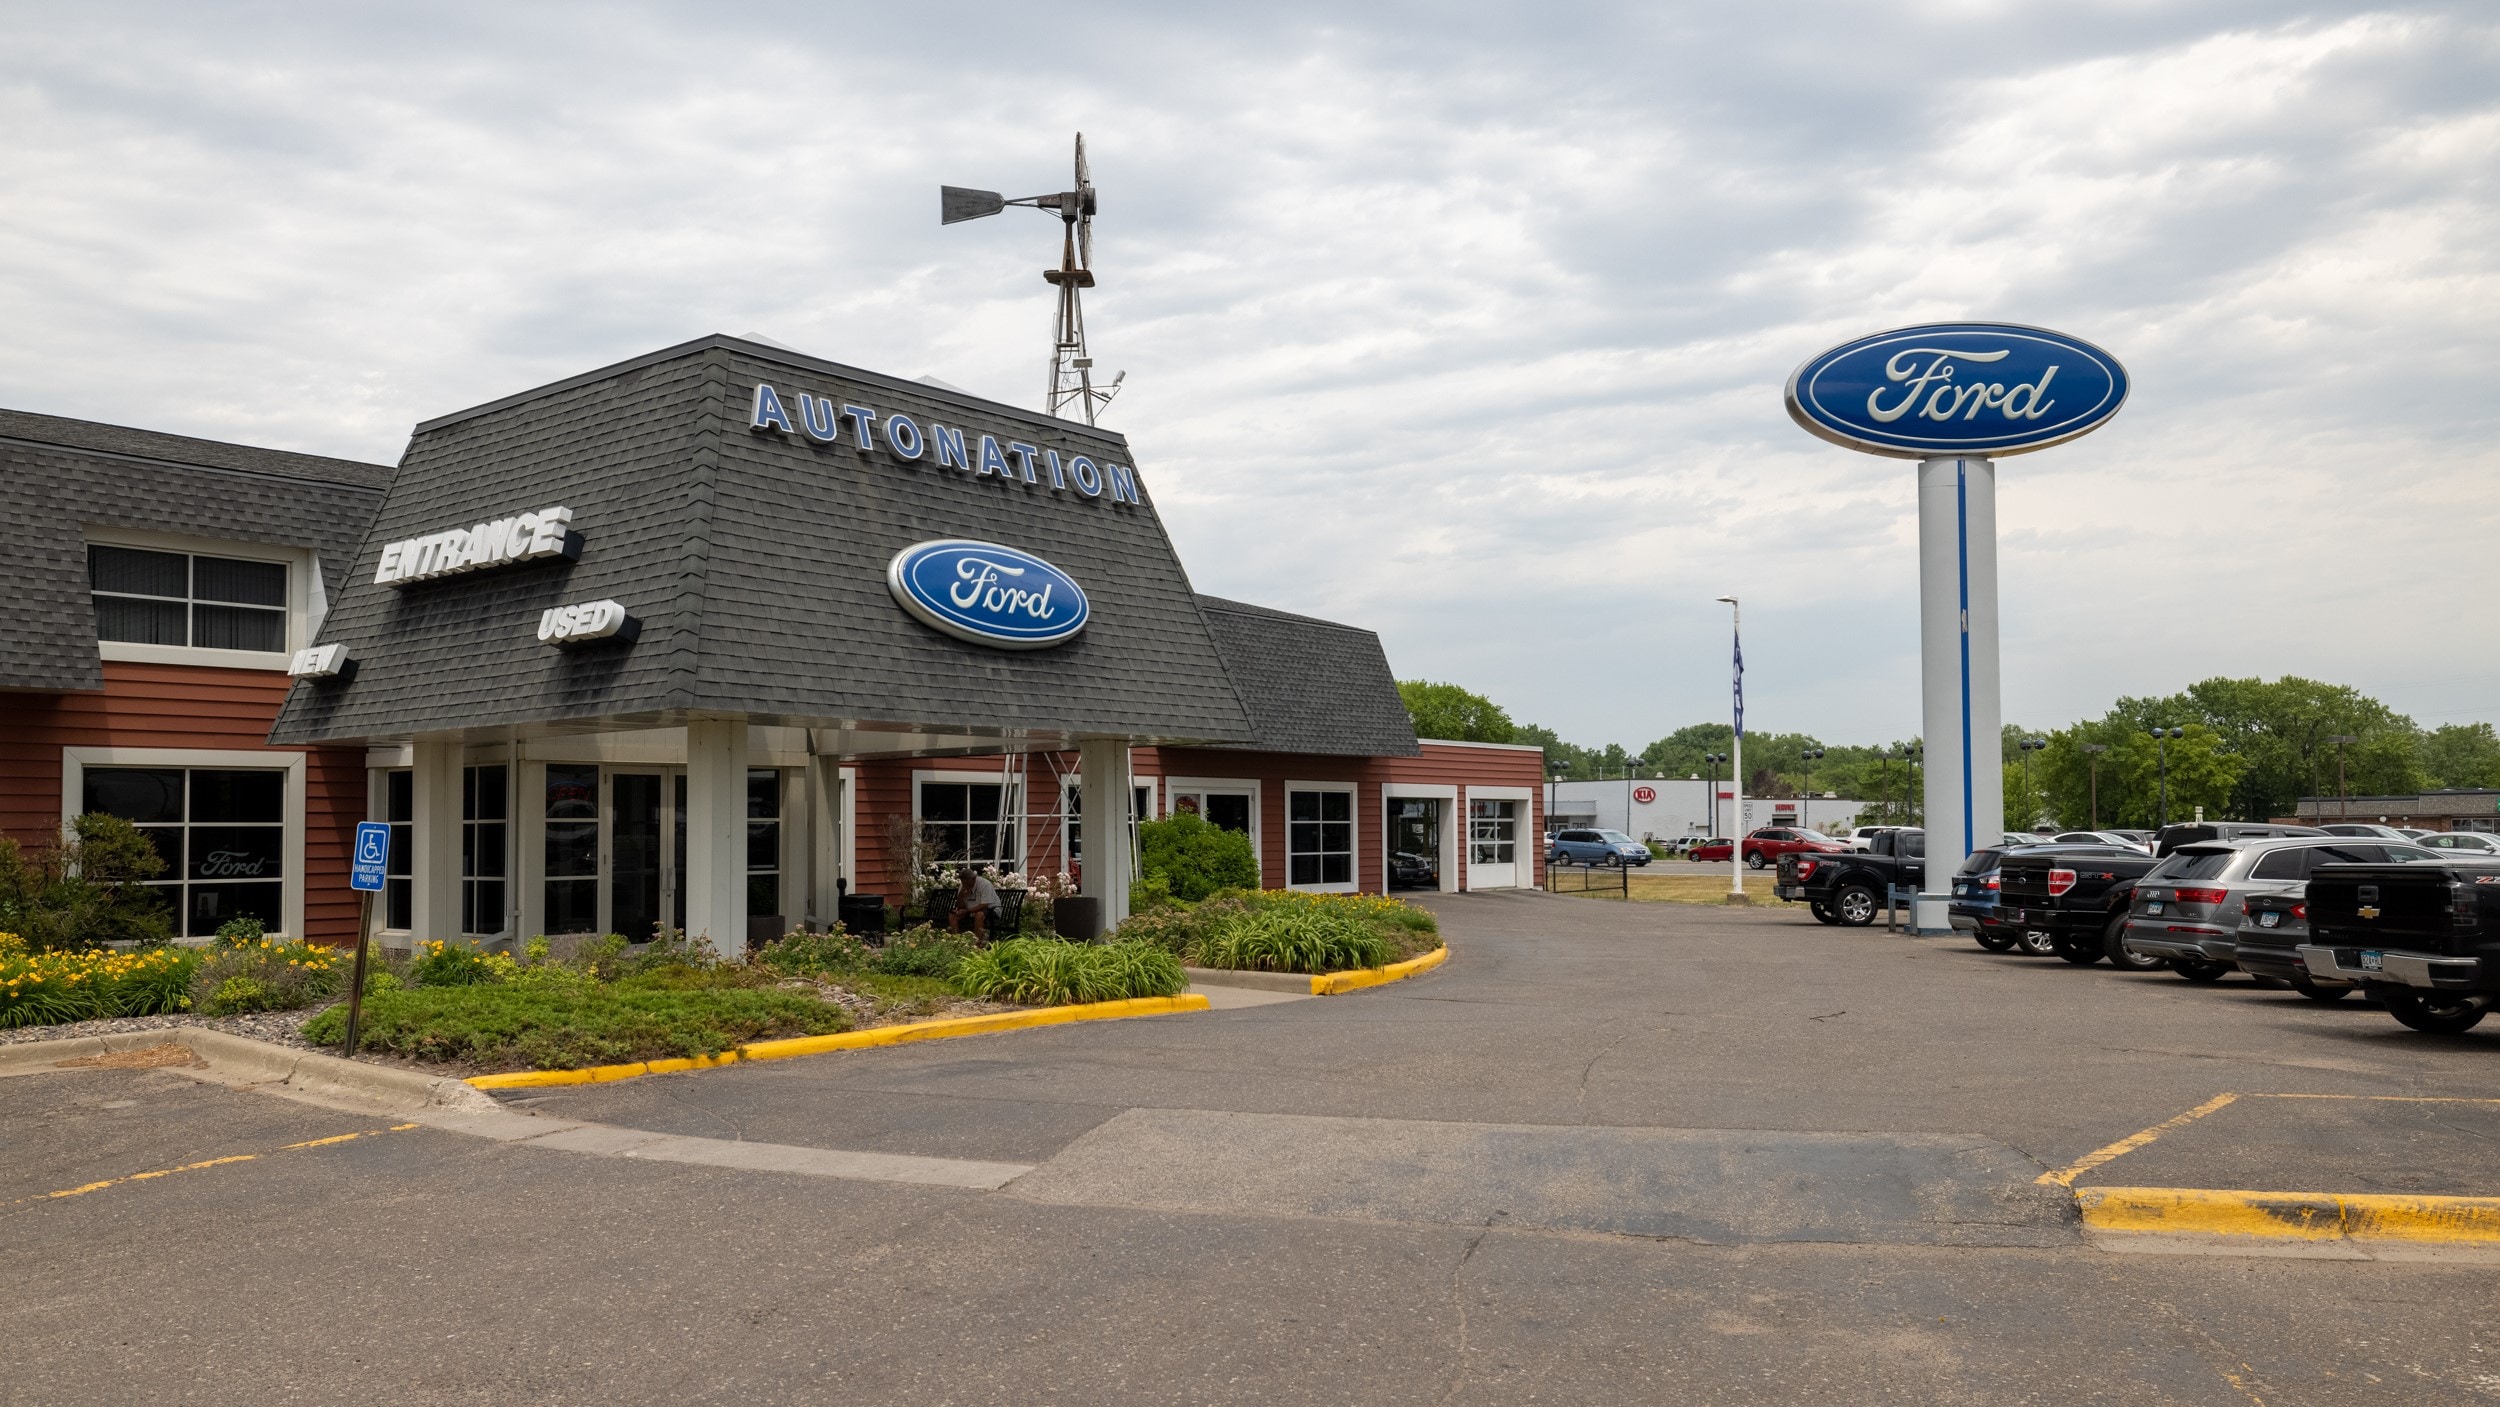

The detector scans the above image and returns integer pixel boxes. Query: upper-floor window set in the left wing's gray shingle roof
[88,547,288,652]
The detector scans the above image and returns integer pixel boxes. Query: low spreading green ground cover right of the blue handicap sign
[305,982,850,1070]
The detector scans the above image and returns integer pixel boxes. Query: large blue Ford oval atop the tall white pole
[1788,322,2128,460]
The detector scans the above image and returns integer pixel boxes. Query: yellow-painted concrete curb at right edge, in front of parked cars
[2075,1187,2500,1260]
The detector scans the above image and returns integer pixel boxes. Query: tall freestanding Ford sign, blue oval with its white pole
[1788,322,2128,932]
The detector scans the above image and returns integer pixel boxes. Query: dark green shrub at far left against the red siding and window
[0,812,173,950]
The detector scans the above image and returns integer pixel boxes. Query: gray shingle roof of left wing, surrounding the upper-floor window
[0,410,393,690]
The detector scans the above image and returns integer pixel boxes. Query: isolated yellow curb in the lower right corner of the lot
[2075,1187,2500,1242]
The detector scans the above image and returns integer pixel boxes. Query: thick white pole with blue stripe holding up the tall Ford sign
[1915,460,2005,932]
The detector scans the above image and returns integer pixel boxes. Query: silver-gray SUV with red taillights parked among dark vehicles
[2123,835,2438,982]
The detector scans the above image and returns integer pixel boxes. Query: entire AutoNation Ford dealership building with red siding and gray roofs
[0,337,1543,947]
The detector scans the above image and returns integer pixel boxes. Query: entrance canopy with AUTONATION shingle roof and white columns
[270,337,1253,947]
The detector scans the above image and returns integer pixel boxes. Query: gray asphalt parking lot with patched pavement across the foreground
[0,895,2500,1405]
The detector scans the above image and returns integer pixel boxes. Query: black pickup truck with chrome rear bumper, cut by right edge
[2300,855,2500,1035]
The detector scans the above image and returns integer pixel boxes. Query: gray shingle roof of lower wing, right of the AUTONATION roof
[1198,595,1423,757]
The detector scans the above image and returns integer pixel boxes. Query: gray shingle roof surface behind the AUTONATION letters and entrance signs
[270,335,1253,742]
